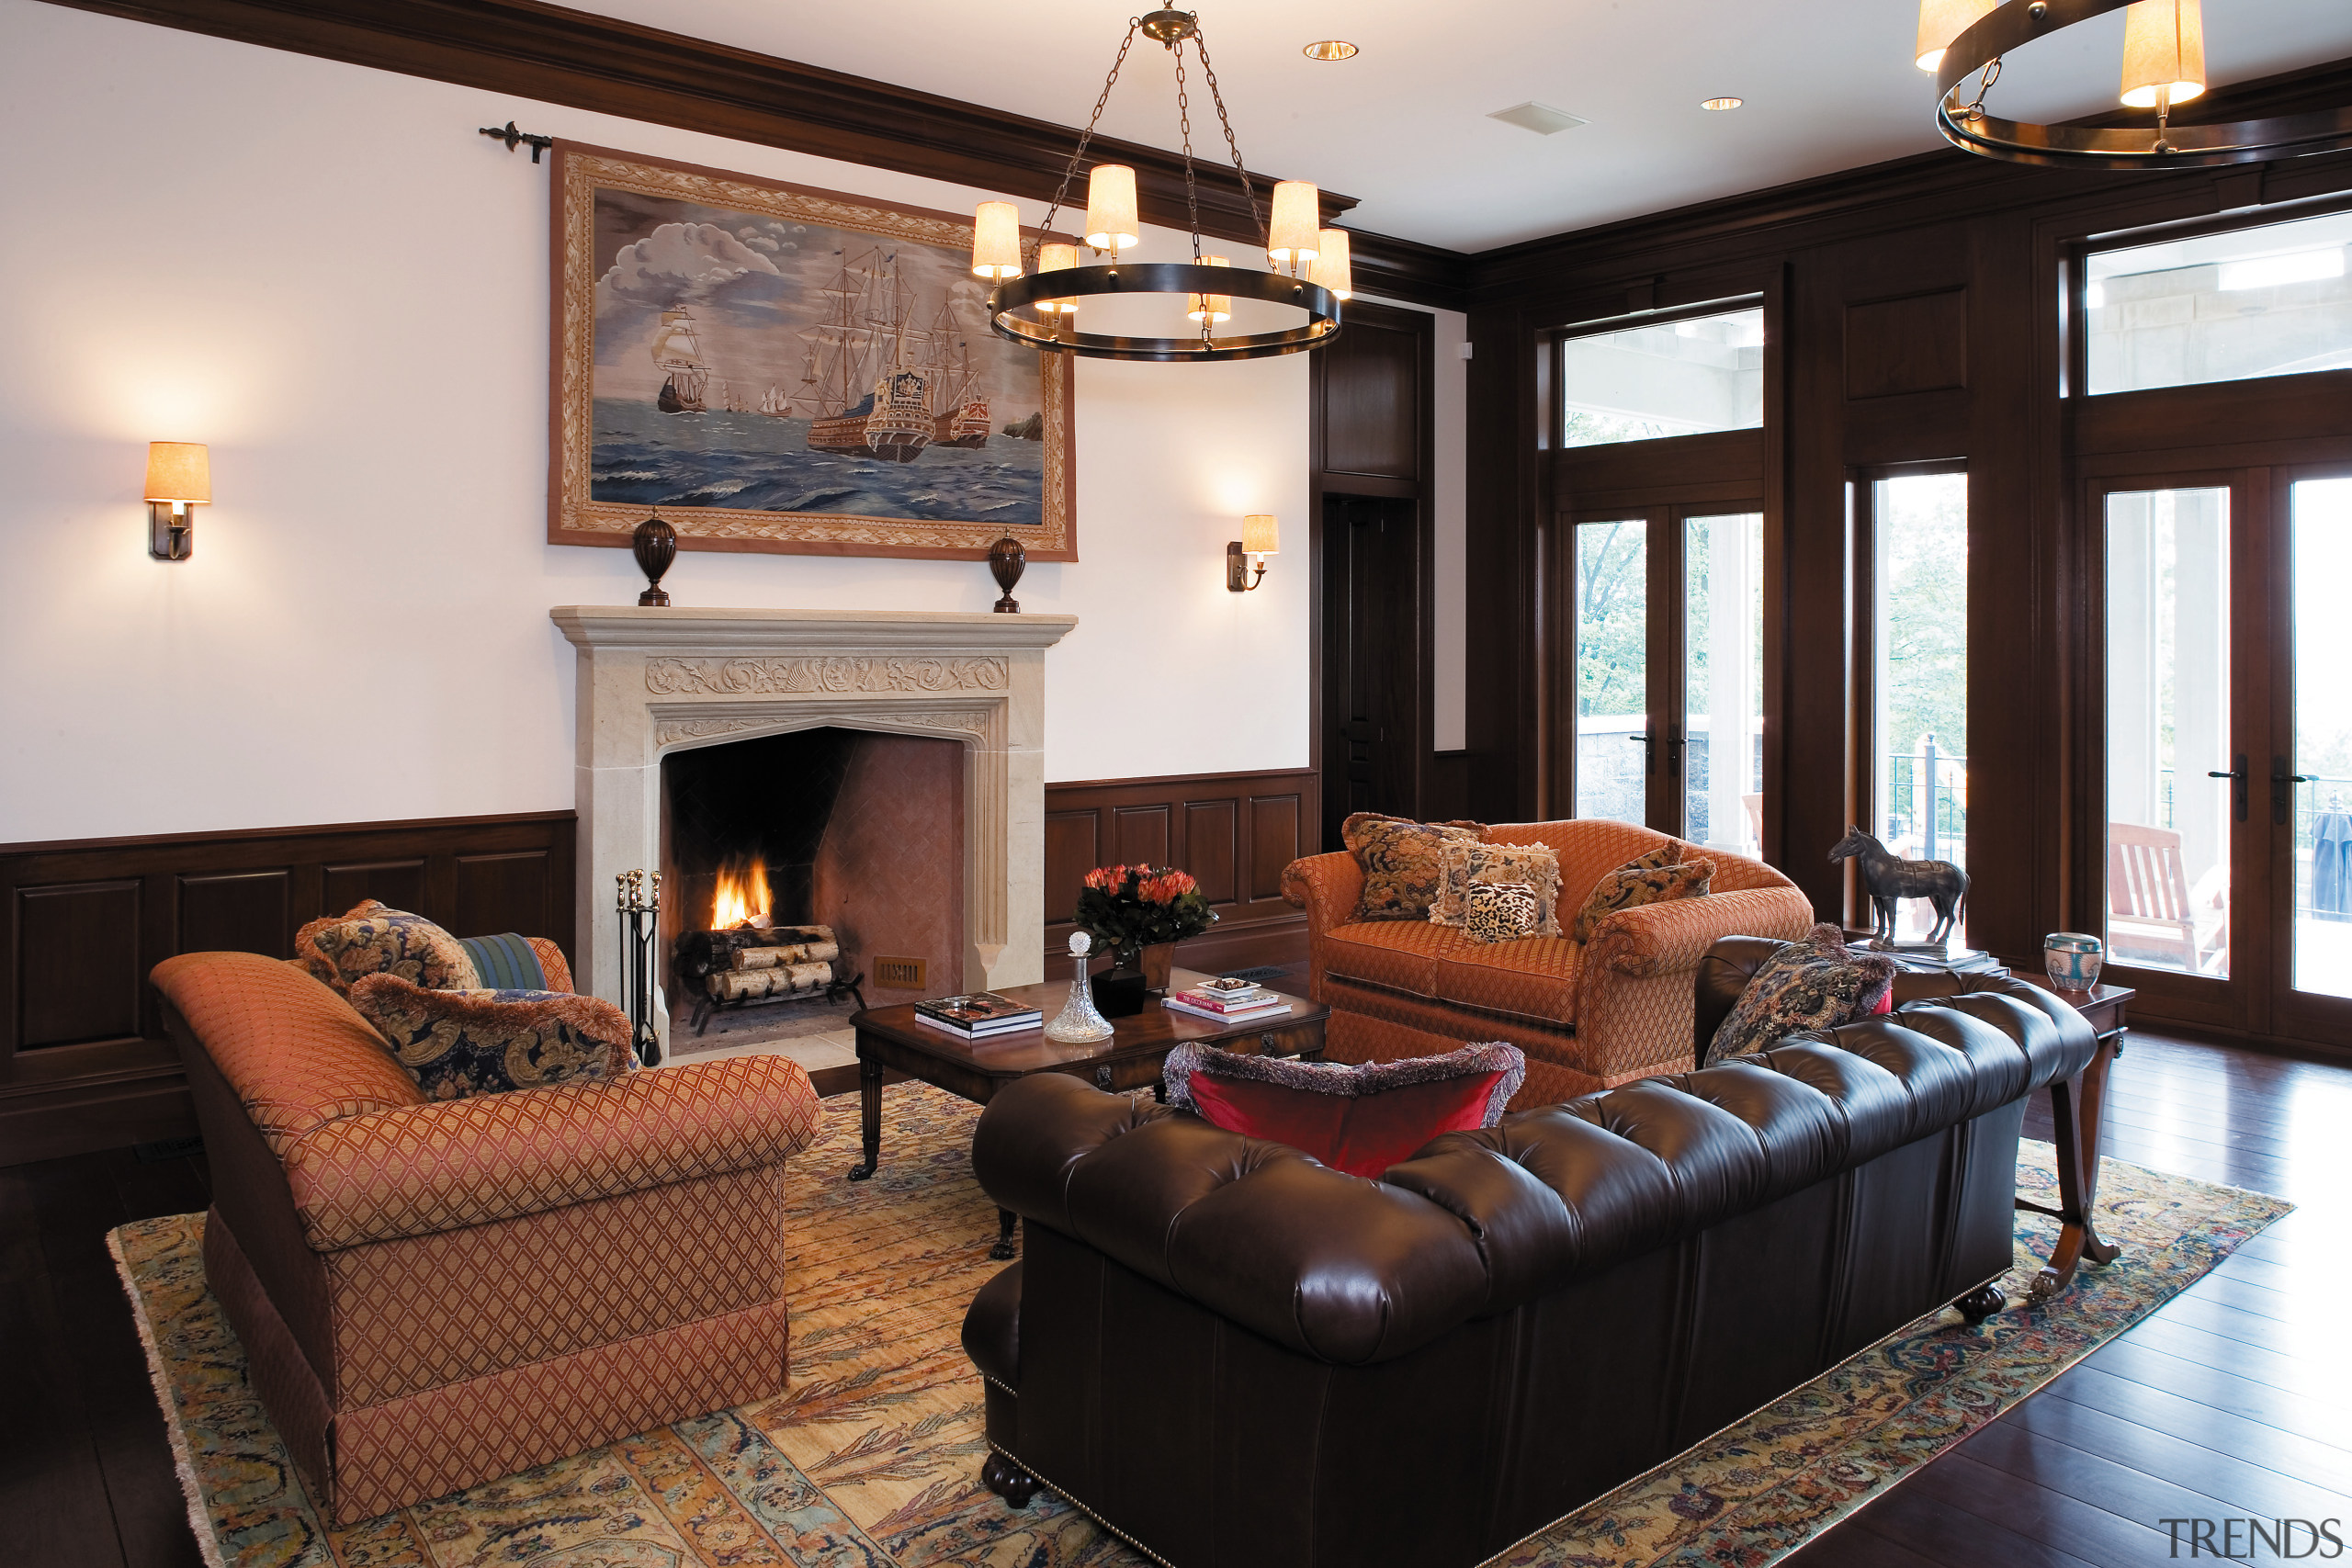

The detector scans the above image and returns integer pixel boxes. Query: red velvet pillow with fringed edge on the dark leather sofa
[1162,1043,1526,1178]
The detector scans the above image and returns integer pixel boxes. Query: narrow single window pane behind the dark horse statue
[1870,472,1969,942]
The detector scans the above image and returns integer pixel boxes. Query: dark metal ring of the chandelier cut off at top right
[1922,0,2352,169]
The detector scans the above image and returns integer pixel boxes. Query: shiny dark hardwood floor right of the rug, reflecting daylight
[1788,1032,2352,1568]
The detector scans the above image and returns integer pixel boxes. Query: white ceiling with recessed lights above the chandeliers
[570,0,2352,252]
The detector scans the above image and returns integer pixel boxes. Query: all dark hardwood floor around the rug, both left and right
[0,1032,2352,1568]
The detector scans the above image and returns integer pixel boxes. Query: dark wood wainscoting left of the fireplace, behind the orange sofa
[0,811,576,1166]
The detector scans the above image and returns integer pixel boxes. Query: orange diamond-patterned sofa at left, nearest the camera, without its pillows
[153,952,819,1526]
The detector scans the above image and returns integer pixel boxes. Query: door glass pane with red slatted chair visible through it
[2108,489,2232,978]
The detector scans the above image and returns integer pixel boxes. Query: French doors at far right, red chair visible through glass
[2088,463,2352,1042]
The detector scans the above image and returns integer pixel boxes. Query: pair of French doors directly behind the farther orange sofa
[1547,503,1764,856]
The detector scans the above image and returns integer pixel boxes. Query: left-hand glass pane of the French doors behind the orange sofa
[1576,517,1649,823]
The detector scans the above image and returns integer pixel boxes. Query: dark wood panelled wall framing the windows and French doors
[1467,63,2352,1043]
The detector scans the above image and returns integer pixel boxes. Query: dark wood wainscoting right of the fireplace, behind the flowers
[1045,769,1319,980]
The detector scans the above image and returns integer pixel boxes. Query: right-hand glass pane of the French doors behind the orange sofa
[1681,513,1764,856]
